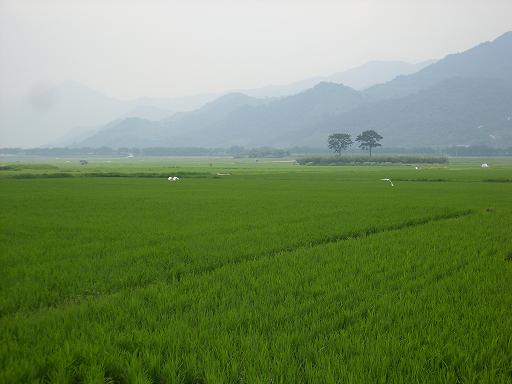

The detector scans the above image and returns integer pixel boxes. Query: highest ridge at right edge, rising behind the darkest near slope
[365,32,512,98]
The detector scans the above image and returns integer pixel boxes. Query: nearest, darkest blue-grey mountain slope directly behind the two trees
[304,78,512,147]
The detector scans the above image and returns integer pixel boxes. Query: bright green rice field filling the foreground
[0,159,512,383]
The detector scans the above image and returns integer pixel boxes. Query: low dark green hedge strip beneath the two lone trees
[297,156,448,165]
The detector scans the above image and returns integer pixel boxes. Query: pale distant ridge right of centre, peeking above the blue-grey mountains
[241,60,434,97]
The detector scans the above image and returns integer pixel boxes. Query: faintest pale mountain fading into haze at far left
[0,81,217,145]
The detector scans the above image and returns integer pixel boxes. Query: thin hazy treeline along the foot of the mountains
[0,146,512,158]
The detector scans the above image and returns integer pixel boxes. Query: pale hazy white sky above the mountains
[0,0,512,102]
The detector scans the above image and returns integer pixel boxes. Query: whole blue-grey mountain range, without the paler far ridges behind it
[66,32,512,147]
